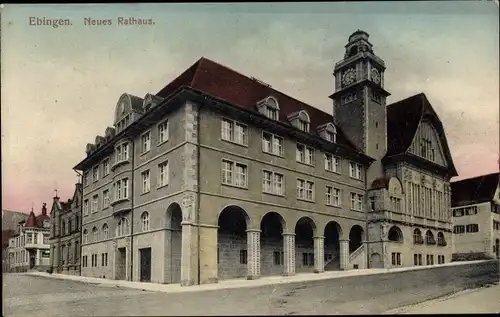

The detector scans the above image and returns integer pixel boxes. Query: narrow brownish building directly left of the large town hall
[50,183,82,275]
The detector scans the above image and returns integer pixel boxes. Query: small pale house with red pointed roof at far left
[8,203,50,272]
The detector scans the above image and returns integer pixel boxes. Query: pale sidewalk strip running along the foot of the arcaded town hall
[22,261,492,293]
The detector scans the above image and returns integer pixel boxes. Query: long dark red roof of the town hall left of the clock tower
[156,57,360,152]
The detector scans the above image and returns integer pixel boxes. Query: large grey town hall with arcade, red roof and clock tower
[75,31,457,285]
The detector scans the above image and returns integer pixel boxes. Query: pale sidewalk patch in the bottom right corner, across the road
[384,284,500,315]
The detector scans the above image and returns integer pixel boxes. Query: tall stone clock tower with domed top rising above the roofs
[330,30,390,188]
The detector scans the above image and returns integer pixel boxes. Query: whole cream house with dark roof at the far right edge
[451,173,500,260]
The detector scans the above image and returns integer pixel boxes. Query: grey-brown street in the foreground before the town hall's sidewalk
[3,268,500,317]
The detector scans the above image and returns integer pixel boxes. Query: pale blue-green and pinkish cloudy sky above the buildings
[0,1,499,214]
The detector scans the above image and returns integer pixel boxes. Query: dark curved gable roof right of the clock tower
[385,93,458,176]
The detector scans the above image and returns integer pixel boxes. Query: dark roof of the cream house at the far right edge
[451,173,499,207]
